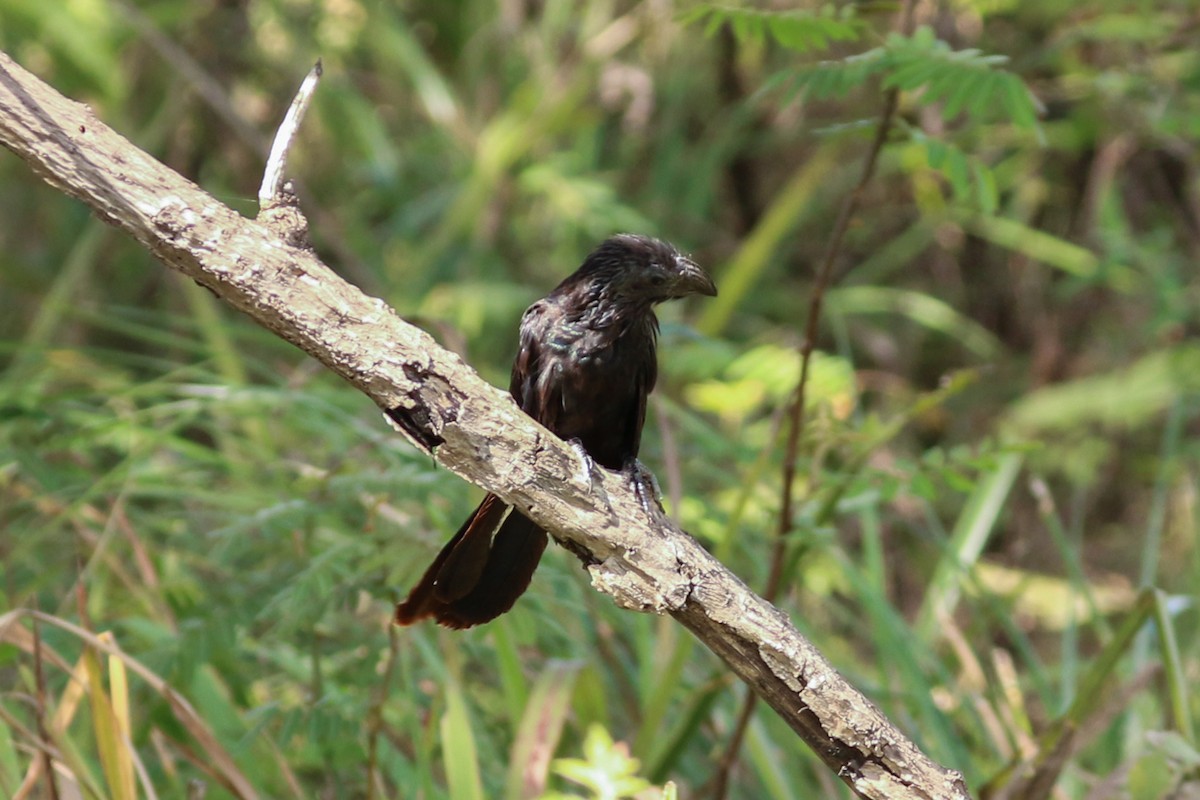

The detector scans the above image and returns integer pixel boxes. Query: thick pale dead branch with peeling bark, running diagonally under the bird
[0,53,968,799]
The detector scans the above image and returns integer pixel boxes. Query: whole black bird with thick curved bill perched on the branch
[396,234,716,627]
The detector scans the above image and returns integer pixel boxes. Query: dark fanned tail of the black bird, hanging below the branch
[395,494,547,628]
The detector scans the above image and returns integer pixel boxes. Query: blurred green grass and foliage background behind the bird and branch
[0,0,1200,799]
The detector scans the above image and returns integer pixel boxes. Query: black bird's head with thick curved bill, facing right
[577,234,716,305]
